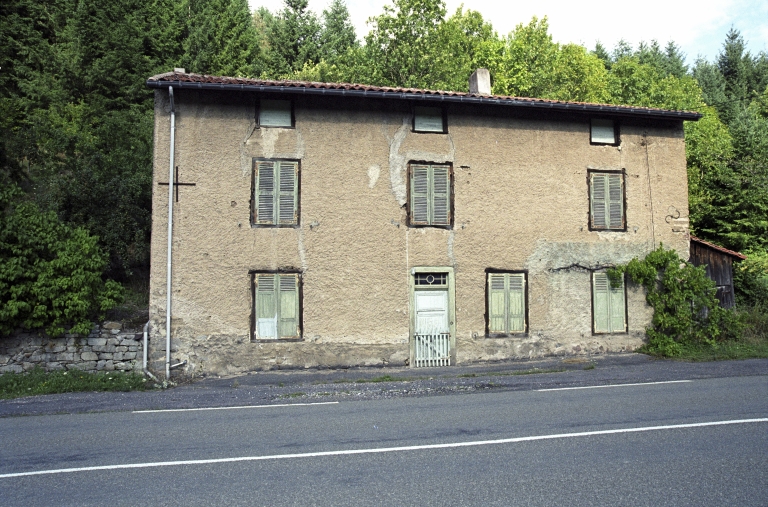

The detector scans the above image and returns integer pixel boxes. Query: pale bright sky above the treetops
[248,0,768,64]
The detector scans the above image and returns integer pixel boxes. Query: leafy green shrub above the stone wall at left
[0,187,123,336]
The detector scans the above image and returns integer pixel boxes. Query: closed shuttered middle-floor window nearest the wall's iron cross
[251,159,299,227]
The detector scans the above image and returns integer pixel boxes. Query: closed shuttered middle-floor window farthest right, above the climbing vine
[588,171,627,231]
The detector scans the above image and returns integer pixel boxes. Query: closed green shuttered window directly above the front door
[408,164,452,227]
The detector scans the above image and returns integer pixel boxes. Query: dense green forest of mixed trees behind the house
[0,0,768,335]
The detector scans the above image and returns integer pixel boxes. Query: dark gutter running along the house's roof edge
[146,80,703,121]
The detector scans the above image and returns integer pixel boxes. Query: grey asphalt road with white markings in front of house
[0,362,768,507]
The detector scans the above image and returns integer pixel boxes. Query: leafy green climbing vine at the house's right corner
[608,245,742,357]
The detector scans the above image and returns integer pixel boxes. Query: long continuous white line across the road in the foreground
[0,417,768,479]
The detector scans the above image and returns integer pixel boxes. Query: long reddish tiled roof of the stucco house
[146,71,702,121]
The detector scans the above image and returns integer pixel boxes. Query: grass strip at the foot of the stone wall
[0,367,147,399]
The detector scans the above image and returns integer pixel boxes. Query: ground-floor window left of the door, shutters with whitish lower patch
[251,273,301,340]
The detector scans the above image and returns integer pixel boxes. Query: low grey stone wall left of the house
[0,322,143,373]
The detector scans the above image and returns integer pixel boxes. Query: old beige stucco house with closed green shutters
[147,69,699,375]
